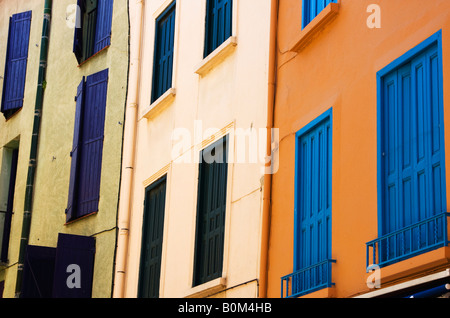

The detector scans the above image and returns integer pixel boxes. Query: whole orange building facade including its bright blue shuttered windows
[266,0,450,298]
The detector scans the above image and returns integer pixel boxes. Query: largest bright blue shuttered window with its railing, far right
[368,32,447,265]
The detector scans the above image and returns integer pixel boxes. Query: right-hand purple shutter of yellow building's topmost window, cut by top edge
[94,0,114,54]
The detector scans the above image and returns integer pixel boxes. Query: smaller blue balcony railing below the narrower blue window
[281,259,336,298]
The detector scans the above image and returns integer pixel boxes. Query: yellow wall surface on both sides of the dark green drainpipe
[0,0,128,297]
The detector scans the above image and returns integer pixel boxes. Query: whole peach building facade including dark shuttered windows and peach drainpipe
[113,0,273,297]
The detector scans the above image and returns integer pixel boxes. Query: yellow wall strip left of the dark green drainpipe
[0,0,44,297]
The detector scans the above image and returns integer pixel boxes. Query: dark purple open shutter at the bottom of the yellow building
[53,233,95,298]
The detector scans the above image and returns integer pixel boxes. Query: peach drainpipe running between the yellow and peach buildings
[113,0,144,298]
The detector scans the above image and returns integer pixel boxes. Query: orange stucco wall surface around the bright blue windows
[267,0,450,297]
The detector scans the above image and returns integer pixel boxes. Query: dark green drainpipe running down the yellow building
[16,0,52,298]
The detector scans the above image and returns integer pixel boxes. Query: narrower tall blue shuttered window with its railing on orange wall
[282,109,334,297]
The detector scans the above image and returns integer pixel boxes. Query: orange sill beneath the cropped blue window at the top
[289,2,339,53]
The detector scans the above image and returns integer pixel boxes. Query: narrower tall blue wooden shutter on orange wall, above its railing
[294,117,332,270]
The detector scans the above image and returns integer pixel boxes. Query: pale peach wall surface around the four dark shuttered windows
[121,0,270,297]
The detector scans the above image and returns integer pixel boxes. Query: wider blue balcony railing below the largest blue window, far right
[366,212,450,268]
